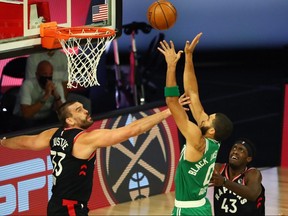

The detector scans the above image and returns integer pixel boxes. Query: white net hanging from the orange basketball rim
[59,29,115,88]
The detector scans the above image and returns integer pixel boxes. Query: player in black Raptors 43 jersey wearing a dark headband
[211,139,265,216]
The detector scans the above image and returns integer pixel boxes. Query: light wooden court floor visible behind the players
[89,167,288,216]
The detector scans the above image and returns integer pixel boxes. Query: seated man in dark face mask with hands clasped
[14,60,66,126]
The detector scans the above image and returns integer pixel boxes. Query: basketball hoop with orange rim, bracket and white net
[40,22,116,88]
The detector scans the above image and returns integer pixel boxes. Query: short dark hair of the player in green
[212,113,233,142]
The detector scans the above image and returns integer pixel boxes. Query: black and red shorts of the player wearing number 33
[47,197,89,216]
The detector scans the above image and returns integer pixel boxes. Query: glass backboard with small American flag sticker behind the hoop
[0,0,122,59]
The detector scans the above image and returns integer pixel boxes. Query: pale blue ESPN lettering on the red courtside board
[0,156,52,215]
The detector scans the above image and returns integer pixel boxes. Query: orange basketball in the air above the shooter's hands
[147,0,177,30]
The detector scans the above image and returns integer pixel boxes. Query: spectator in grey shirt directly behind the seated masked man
[25,49,91,113]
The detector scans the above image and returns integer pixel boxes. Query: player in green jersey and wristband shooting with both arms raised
[158,33,233,216]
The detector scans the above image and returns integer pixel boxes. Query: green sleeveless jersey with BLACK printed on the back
[175,138,220,201]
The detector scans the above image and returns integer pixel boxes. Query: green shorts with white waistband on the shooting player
[171,198,212,216]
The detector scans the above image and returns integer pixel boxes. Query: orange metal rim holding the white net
[55,26,115,40]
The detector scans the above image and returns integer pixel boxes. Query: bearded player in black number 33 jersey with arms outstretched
[1,102,176,216]
